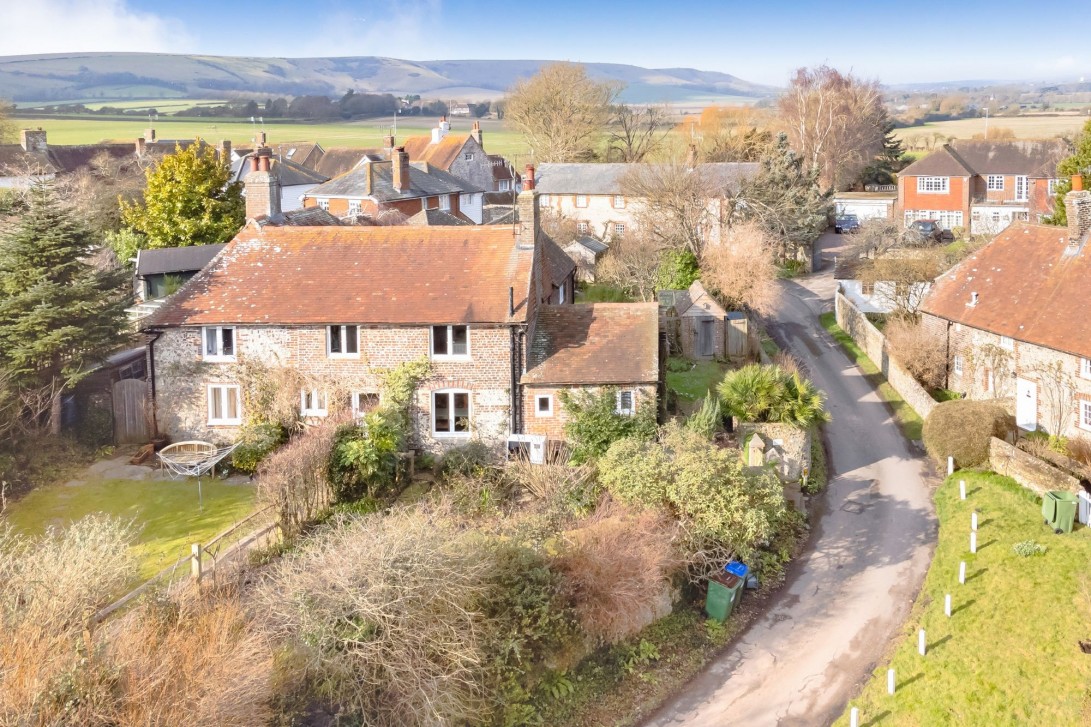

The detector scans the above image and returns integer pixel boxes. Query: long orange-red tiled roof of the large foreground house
[146,224,533,327]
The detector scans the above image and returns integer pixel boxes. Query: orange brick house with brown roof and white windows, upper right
[895,139,1068,235]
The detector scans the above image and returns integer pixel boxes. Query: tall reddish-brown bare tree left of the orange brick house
[779,65,884,190]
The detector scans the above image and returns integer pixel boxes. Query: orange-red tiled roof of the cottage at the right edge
[921,224,1091,358]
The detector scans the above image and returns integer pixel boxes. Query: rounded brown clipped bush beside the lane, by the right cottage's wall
[924,400,1014,468]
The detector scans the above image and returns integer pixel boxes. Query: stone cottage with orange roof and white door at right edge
[920,179,1091,437]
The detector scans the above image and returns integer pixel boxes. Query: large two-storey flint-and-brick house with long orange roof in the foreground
[144,176,632,452]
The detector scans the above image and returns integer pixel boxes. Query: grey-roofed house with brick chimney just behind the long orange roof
[303,147,485,225]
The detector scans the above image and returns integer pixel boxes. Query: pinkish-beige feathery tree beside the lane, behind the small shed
[700,222,780,314]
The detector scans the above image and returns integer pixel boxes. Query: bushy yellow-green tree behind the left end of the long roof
[120,140,245,248]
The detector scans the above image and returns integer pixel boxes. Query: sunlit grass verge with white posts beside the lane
[836,472,1091,727]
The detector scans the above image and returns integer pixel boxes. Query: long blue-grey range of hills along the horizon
[0,52,776,103]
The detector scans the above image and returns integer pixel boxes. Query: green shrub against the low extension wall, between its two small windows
[559,386,656,464]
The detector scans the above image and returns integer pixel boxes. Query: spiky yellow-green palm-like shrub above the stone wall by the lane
[717,364,829,427]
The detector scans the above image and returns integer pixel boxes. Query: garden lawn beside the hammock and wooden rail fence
[5,479,254,577]
